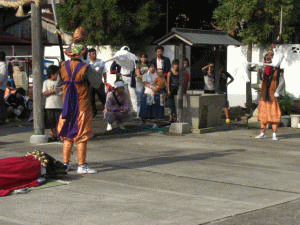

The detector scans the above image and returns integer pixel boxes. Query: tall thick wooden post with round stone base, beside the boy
[30,3,47,143]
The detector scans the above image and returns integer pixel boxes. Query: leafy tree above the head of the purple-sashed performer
[57,0,161,50]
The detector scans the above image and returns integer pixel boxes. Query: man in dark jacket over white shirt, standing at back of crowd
[151,45,171,75]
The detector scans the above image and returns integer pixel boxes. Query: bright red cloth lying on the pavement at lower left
[0,156,41,197]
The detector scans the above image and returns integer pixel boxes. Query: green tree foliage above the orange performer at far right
[213,0,300,45]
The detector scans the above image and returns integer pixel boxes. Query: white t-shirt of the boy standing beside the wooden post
[43,79,63,109]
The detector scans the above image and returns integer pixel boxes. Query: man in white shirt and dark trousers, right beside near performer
[87,48,106,117]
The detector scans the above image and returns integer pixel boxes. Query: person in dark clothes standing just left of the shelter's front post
[167,60,180,123]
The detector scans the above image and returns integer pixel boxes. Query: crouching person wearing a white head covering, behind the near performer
[103,81,132,131]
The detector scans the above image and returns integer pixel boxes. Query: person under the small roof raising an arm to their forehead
[202,63,216,94]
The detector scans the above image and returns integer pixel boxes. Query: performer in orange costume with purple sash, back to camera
[58,27,102,174]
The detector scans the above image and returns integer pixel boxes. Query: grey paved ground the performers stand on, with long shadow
[0,117,300,225]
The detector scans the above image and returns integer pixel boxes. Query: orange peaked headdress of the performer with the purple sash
[65,27,87,58]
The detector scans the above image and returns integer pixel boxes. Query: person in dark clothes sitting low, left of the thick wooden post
[5,88,27,120]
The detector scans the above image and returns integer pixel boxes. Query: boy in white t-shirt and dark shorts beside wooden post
[43,65,63,141]
